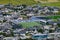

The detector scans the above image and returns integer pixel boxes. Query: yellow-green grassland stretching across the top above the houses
[0,0,60,7]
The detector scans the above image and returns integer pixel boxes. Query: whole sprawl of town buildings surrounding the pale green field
[0,5,60,40]
